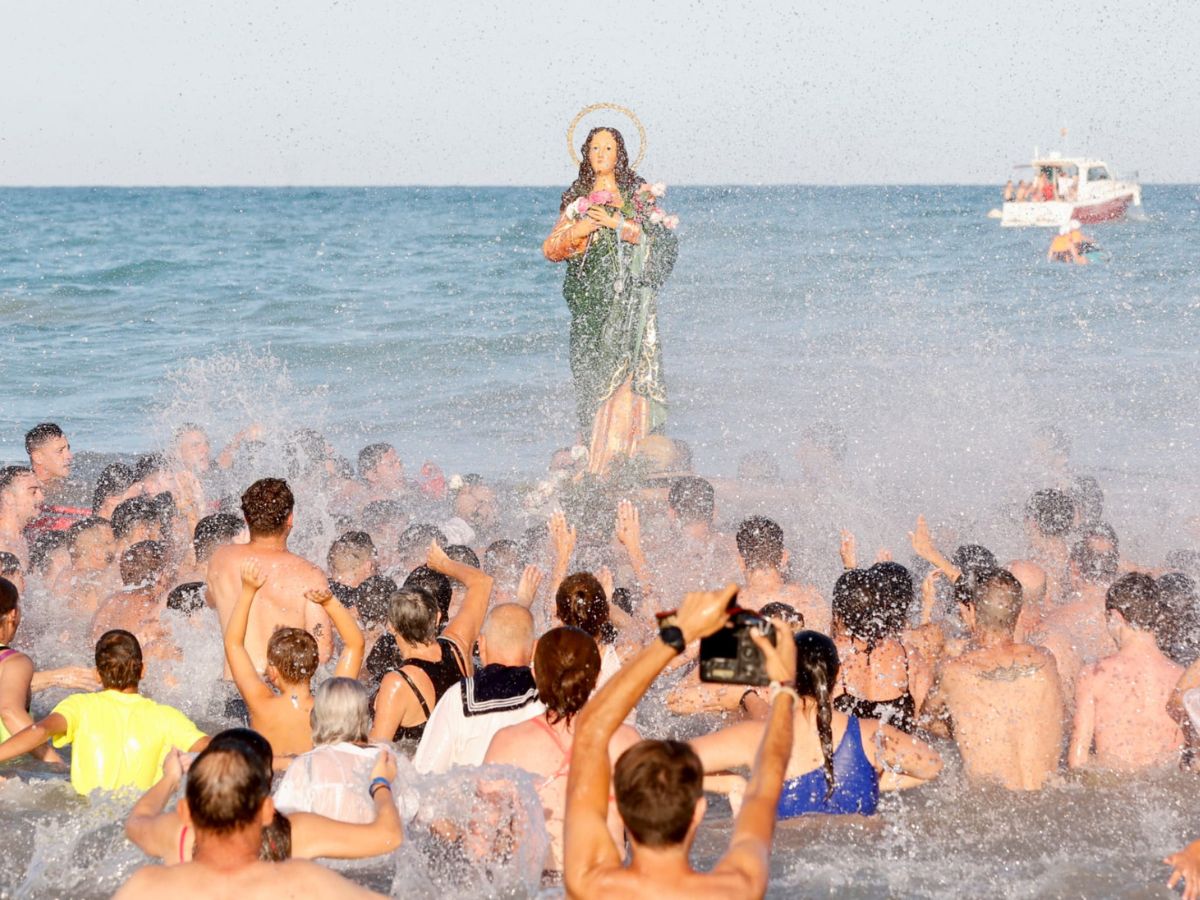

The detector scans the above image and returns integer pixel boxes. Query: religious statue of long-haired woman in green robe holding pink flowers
[542,127,678,473]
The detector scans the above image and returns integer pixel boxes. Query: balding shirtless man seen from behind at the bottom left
[116,742,382,900]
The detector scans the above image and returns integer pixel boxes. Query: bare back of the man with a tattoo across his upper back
[941,643,1063,791]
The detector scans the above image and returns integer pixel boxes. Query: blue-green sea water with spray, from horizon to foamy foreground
[0,186,1200,896]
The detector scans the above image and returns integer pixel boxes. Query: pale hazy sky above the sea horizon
[0,0,1200,185]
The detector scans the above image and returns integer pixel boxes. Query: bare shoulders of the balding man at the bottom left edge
[116,859,382,900]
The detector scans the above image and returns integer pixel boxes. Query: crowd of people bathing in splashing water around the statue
[0,424,1200,898]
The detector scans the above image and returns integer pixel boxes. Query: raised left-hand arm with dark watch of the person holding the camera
[563,584,737,895]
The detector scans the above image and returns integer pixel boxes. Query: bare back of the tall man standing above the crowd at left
[208,538,334,678]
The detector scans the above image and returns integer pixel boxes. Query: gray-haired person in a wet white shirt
[275,678,416,823]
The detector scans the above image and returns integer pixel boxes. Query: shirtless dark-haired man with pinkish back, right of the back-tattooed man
[1067,574,1183,772]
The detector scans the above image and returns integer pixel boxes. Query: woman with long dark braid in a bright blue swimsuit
[691,630,942,818]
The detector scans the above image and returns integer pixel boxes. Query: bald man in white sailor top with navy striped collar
[413,604,546,773]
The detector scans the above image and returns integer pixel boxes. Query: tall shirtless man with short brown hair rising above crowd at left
[208,478,334,678]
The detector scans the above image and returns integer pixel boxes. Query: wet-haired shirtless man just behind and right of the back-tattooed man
[1031,542,1117,697]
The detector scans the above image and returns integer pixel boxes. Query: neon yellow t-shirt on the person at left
[54,690,204,794]
